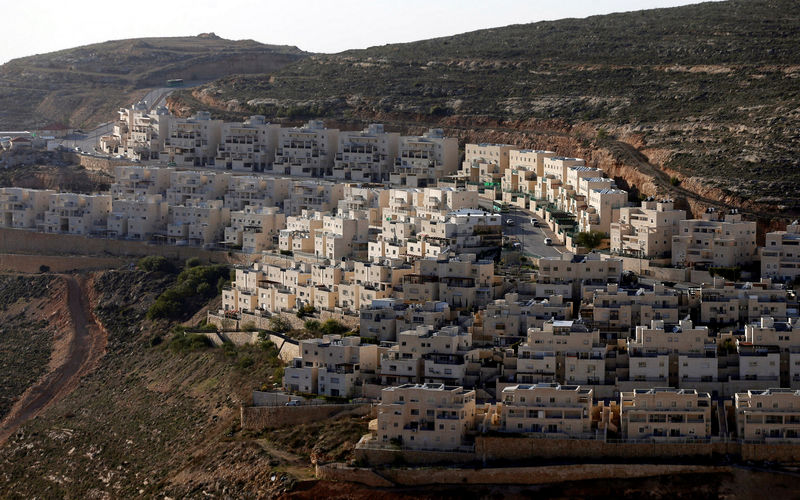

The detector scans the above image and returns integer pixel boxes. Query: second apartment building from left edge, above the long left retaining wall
[44,193,111,235]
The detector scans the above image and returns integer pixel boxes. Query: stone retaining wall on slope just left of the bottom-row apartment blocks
[241,404,372,431]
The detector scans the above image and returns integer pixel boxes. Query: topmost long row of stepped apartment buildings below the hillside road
[105,102,458,187]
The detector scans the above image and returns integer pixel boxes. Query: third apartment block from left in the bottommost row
[620,388,711,441]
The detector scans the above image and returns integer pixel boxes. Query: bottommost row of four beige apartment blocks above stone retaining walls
[359,383,800,451]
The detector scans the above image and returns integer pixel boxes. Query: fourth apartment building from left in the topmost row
[267,120,339,177]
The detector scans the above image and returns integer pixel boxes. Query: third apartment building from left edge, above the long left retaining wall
[108,194,168,240]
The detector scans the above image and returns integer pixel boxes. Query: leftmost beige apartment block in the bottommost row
[376,384,475,451]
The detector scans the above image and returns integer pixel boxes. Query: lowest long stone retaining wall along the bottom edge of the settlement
[316,464,733,487]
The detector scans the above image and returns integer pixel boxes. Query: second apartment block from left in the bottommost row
[497,383,593,438]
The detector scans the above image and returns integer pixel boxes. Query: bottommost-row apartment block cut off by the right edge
[734,389,800,443]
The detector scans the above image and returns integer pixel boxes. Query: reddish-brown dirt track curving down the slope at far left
[0,275,108,445]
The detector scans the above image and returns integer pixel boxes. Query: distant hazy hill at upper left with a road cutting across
[0,33,306,130]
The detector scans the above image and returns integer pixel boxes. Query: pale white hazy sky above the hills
[0,0,712,63]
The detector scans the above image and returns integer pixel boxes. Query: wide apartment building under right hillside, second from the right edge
[672,209,757,267]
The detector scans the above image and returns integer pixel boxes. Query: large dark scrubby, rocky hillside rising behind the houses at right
[171,0,800,215]
